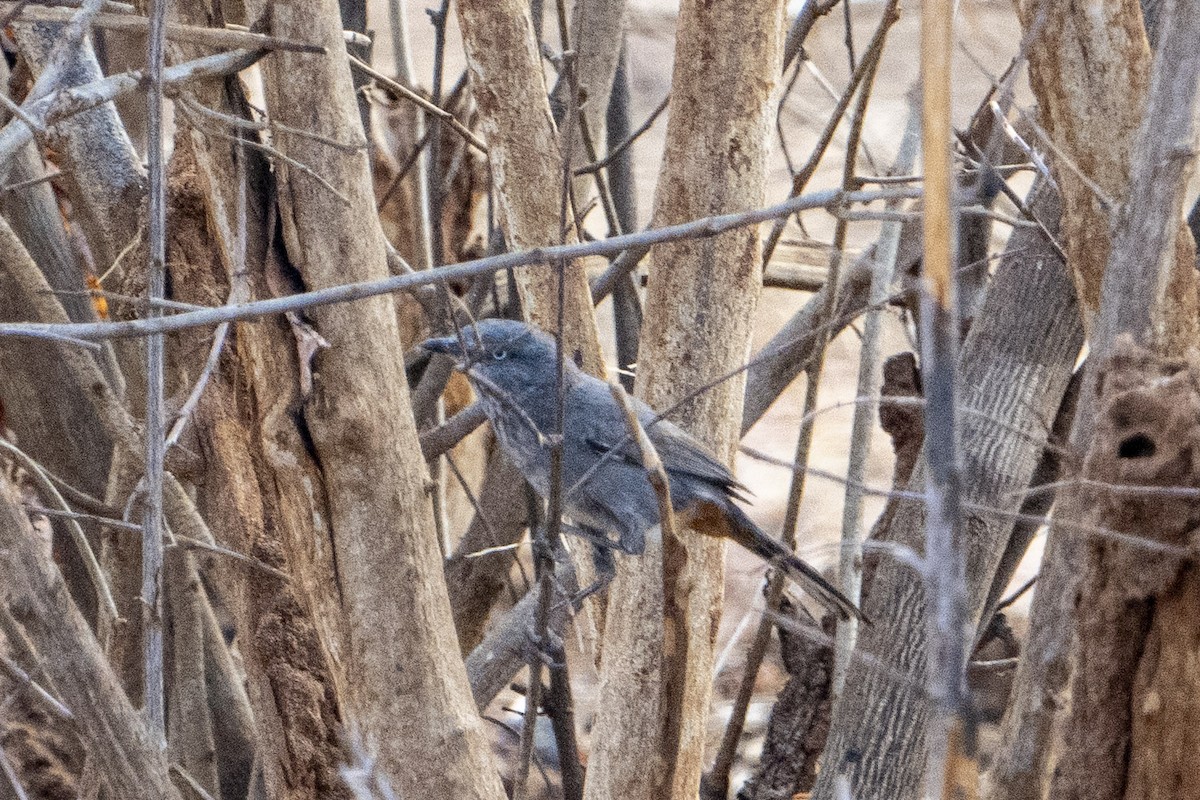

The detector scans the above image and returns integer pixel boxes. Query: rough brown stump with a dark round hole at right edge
[1051,341,1200,800]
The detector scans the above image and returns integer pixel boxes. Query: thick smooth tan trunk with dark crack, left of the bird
[190,0,502,798]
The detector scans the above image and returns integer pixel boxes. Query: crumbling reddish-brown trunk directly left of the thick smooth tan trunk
[168,130,343,798]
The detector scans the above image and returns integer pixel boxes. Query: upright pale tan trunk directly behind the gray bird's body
[584,0,784,799]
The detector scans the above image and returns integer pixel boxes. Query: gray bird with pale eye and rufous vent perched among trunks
[424,319,863,619]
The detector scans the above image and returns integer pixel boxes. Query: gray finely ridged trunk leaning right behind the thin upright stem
[814,188,1082,800]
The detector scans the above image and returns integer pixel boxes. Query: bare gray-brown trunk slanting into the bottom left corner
[0,476,179,800]
